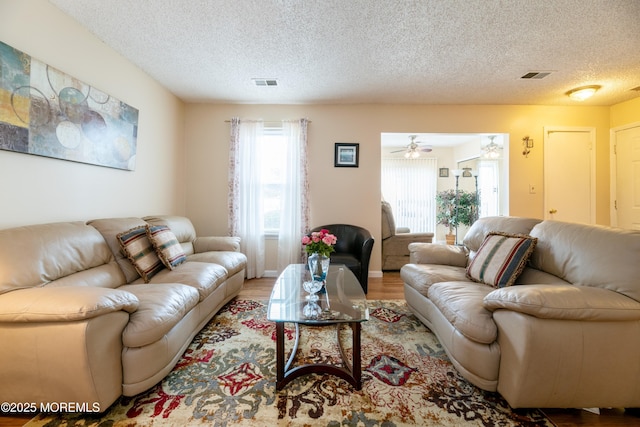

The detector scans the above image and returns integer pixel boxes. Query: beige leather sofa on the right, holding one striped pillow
[401,217,640,408]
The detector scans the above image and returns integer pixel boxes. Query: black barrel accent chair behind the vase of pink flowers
[311,224,373,294]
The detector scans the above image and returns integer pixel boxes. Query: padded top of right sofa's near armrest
[483,285,640,321]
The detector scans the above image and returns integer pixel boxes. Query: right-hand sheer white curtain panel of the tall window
[278,119,309,273]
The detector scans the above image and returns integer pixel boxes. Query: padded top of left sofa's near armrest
[0,286,138,322]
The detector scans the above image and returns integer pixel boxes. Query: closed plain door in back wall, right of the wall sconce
[544,127,595,224]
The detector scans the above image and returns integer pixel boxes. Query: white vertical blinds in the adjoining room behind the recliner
[382,158,438,233]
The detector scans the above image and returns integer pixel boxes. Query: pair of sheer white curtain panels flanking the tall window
[229,118,309,279]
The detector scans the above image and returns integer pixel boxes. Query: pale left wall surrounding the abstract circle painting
[0,0,186,228]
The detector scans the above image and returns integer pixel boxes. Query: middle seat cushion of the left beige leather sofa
[139,261,228,301]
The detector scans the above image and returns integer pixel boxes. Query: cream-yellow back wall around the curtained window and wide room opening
[185,104,610,271]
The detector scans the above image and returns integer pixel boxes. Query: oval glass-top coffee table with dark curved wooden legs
[267,264,369,390]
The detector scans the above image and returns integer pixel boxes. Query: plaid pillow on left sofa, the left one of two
[116,225,164,283]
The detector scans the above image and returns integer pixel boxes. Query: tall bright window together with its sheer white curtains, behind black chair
[229,117,309,279]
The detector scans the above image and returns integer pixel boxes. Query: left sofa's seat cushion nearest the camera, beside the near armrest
[118,283,199,347]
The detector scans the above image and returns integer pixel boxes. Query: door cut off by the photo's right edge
[611,123,640,230]
